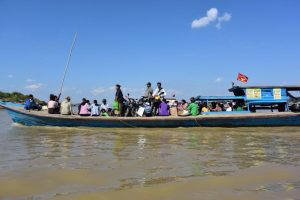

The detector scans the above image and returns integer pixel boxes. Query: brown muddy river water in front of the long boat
[0,110,300,200]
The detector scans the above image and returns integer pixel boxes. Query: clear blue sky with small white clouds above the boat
[0,0,300,101]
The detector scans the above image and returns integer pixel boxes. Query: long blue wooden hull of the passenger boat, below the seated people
[3,105,300,128]
